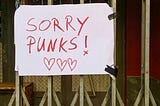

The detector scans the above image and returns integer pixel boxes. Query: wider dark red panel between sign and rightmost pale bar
[126,0,141,76]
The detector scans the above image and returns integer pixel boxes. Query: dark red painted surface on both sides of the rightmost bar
[126,0,160,80]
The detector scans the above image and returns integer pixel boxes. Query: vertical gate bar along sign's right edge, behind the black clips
[111,0,117,106]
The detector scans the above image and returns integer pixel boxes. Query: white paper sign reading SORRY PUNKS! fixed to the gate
[14,3,114,76]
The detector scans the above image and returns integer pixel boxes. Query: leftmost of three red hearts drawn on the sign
[43,57,55,71]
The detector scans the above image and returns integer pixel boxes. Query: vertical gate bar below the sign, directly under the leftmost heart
[48,76,53,106]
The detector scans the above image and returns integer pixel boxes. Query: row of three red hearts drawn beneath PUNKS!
[43,57,77,72]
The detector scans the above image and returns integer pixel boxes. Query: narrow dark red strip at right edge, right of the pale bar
[150,0,160,80]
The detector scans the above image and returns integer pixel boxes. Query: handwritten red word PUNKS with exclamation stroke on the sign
[27,35,87,54]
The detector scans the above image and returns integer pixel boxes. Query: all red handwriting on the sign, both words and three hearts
[26,15,89,72]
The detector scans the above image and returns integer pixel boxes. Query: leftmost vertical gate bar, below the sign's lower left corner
[16,71,22,106]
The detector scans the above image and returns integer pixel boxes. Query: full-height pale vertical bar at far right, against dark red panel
[144,0,150,106]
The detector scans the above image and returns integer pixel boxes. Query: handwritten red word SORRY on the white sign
[26,15,89,36]
